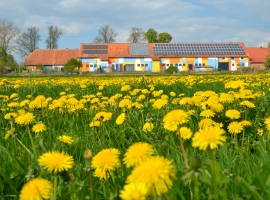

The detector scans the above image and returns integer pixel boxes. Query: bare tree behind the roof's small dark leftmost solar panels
[93,25,118,43]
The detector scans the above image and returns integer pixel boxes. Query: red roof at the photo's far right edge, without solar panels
[245,47,270,63]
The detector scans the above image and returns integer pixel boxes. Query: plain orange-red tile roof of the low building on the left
[24,49,79,66]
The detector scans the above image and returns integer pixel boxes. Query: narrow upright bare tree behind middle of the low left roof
[46,26,63,49]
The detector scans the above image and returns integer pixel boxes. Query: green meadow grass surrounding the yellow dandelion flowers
[0,73,270,199]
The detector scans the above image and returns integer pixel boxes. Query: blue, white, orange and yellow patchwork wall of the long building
[81,57,248,72]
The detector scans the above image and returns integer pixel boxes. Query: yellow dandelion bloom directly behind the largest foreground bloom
[123,142,154,168]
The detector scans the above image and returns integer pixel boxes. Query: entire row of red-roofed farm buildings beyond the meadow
[24,42,269,72]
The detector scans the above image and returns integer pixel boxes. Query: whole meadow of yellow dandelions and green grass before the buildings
[0,73,270,200]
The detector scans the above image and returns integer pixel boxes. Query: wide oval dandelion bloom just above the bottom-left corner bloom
[38,151,74,173]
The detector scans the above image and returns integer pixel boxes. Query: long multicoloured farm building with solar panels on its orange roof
[79,42,249,72]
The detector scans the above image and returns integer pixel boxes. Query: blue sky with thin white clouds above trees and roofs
[0,0,270,60]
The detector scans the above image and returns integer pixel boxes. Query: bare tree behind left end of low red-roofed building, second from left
[16,27,41,57]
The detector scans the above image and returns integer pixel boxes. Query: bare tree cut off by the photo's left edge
[0,19,20,53]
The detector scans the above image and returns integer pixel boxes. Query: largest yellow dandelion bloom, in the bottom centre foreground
[127,156,176,195]
